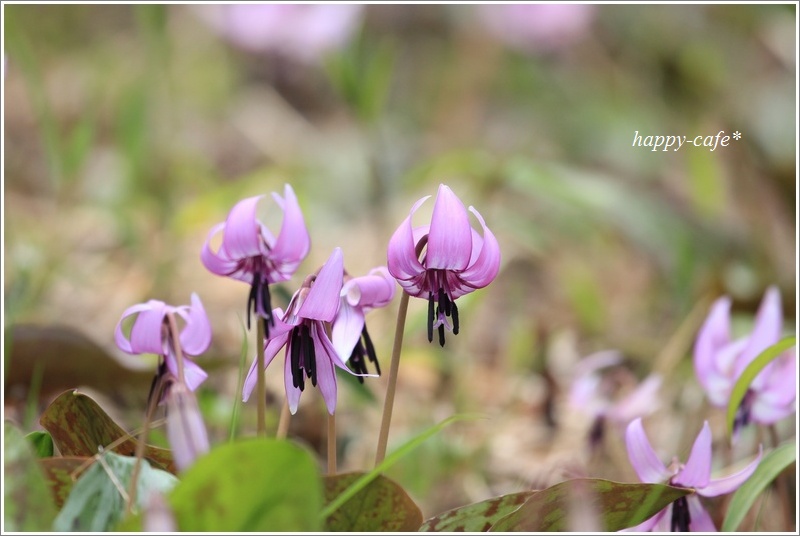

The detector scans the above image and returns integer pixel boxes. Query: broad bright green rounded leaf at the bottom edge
[169,439,323,532]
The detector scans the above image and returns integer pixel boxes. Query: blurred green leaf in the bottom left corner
[3,421,56,532]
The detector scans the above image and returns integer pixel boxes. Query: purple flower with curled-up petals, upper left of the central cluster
[200,184,311,335]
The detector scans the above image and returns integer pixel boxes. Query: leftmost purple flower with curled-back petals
[114,293,211,391]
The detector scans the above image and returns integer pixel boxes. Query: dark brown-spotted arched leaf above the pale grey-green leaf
[39,391,176,474]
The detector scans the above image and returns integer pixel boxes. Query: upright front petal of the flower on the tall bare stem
[425,184,472,271]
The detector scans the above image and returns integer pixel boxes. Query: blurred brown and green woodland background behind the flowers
[3,4,797,530]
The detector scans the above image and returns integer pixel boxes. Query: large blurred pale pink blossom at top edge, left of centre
[197,4,363,62]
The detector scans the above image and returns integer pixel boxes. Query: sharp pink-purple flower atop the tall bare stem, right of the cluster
[388,184,500,346]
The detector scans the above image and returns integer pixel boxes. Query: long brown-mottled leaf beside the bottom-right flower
[490,478,692,532]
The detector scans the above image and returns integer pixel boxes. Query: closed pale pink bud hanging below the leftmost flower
[166,383,210,471]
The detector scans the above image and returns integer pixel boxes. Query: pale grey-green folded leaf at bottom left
[53,452,178,532]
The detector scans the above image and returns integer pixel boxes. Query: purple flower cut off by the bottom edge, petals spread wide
[625,419,761,532]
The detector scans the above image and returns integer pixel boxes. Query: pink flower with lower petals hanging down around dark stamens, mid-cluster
[238,248,362,415]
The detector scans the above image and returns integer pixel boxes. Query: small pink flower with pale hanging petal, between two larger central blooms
[331,266,395,383]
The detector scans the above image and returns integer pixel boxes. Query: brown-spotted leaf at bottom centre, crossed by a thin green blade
[325,473,422,532]
